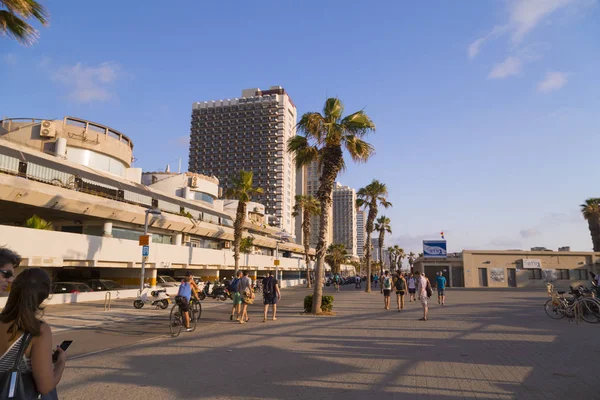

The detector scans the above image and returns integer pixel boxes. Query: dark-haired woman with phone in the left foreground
[0,268,67,395]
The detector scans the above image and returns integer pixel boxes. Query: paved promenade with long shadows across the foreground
[47,286,600,400]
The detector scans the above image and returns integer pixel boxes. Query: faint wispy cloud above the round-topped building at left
[52,62,123,103]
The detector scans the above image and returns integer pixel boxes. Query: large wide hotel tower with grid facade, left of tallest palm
[188,86,297,236]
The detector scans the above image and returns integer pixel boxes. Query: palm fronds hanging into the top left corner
[0,0,48,46]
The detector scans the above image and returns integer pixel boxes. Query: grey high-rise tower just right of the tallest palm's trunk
[333,182,358,257]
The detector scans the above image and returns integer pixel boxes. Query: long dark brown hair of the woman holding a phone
[0,268,52,339]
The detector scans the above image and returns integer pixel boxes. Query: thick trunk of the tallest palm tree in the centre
[312,145,343,314]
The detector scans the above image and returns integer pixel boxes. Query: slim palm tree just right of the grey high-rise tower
[356,179,392,292]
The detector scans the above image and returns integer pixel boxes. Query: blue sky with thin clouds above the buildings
[0,0,600,252]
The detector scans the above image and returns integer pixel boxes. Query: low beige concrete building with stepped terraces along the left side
[0,117,316,294]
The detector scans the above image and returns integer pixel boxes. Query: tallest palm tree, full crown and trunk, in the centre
[287,98,375,314]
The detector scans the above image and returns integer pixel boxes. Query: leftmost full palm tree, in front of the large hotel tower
[225,171,263,275]
